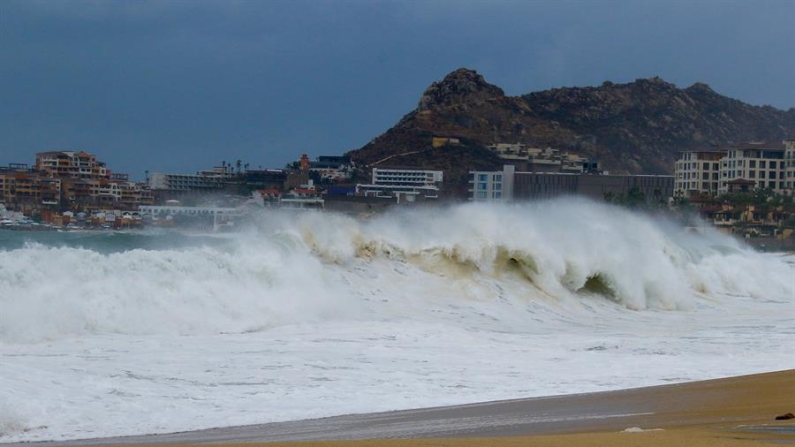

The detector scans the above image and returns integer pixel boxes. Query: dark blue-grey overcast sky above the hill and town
[0,0,795,179]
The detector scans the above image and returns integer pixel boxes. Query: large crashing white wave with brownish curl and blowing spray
[0,200,795,341]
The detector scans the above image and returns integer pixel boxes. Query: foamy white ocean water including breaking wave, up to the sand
[0,200,795,443]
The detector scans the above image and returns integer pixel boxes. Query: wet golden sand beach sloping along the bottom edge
[9,370,795,447]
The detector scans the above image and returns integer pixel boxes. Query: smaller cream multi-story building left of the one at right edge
[674,149,727,197]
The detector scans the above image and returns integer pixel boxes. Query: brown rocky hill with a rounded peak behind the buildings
[349,68,795,192]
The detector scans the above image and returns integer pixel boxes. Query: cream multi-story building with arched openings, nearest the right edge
[718,141,787,194]
